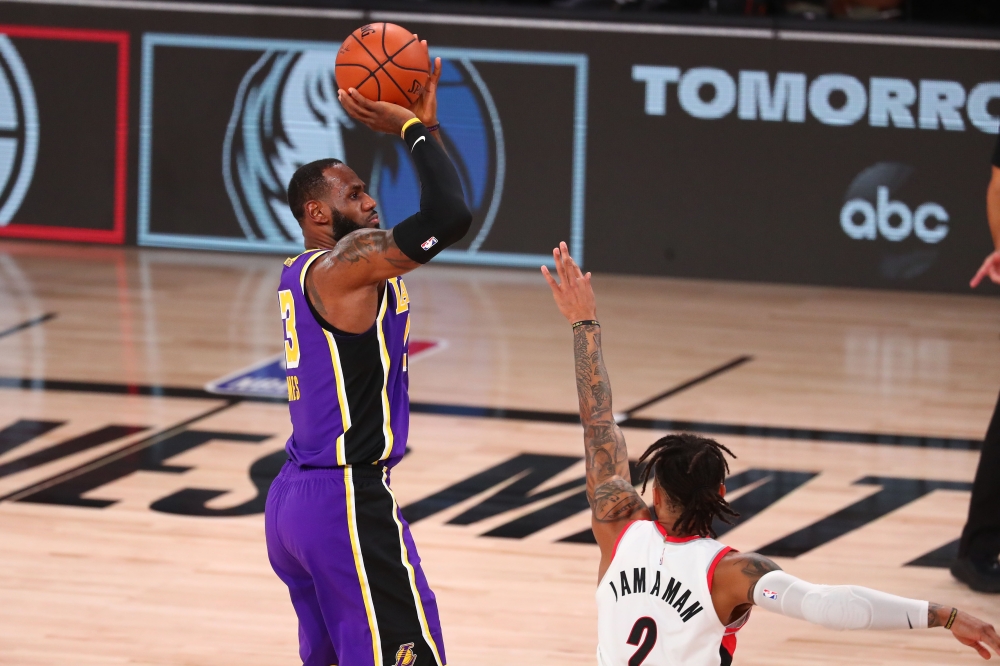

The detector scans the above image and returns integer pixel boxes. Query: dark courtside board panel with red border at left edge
[0,25,130,244]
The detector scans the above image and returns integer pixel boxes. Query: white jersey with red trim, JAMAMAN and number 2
[597,520,750,666]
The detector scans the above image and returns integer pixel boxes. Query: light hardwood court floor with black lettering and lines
[0,242,1000,666]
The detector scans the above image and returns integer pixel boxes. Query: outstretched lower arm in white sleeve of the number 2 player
[712,551,1000,659]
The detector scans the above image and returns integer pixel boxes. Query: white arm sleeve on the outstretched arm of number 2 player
[753,571,928,630]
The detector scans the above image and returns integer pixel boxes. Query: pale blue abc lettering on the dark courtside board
[840,185,948,243]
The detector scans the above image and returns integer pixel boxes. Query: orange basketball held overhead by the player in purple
[336,23,430,108]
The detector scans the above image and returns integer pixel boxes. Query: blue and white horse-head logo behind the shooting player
[229,50,505,246]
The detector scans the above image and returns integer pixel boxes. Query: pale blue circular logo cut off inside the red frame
[0,35,38,226]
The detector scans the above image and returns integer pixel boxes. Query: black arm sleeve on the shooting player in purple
[392,123,472,264]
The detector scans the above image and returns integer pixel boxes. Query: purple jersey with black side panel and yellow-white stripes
[278,250,410,467]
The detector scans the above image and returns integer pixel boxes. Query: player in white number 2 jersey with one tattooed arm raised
[542,243,1000,666]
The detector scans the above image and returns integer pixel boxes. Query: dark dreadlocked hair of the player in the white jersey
[639,433,740,537]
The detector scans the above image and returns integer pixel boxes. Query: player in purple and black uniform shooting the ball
[265,59,471,666]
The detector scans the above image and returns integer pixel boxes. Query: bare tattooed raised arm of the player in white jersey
[542,243,650,573]
